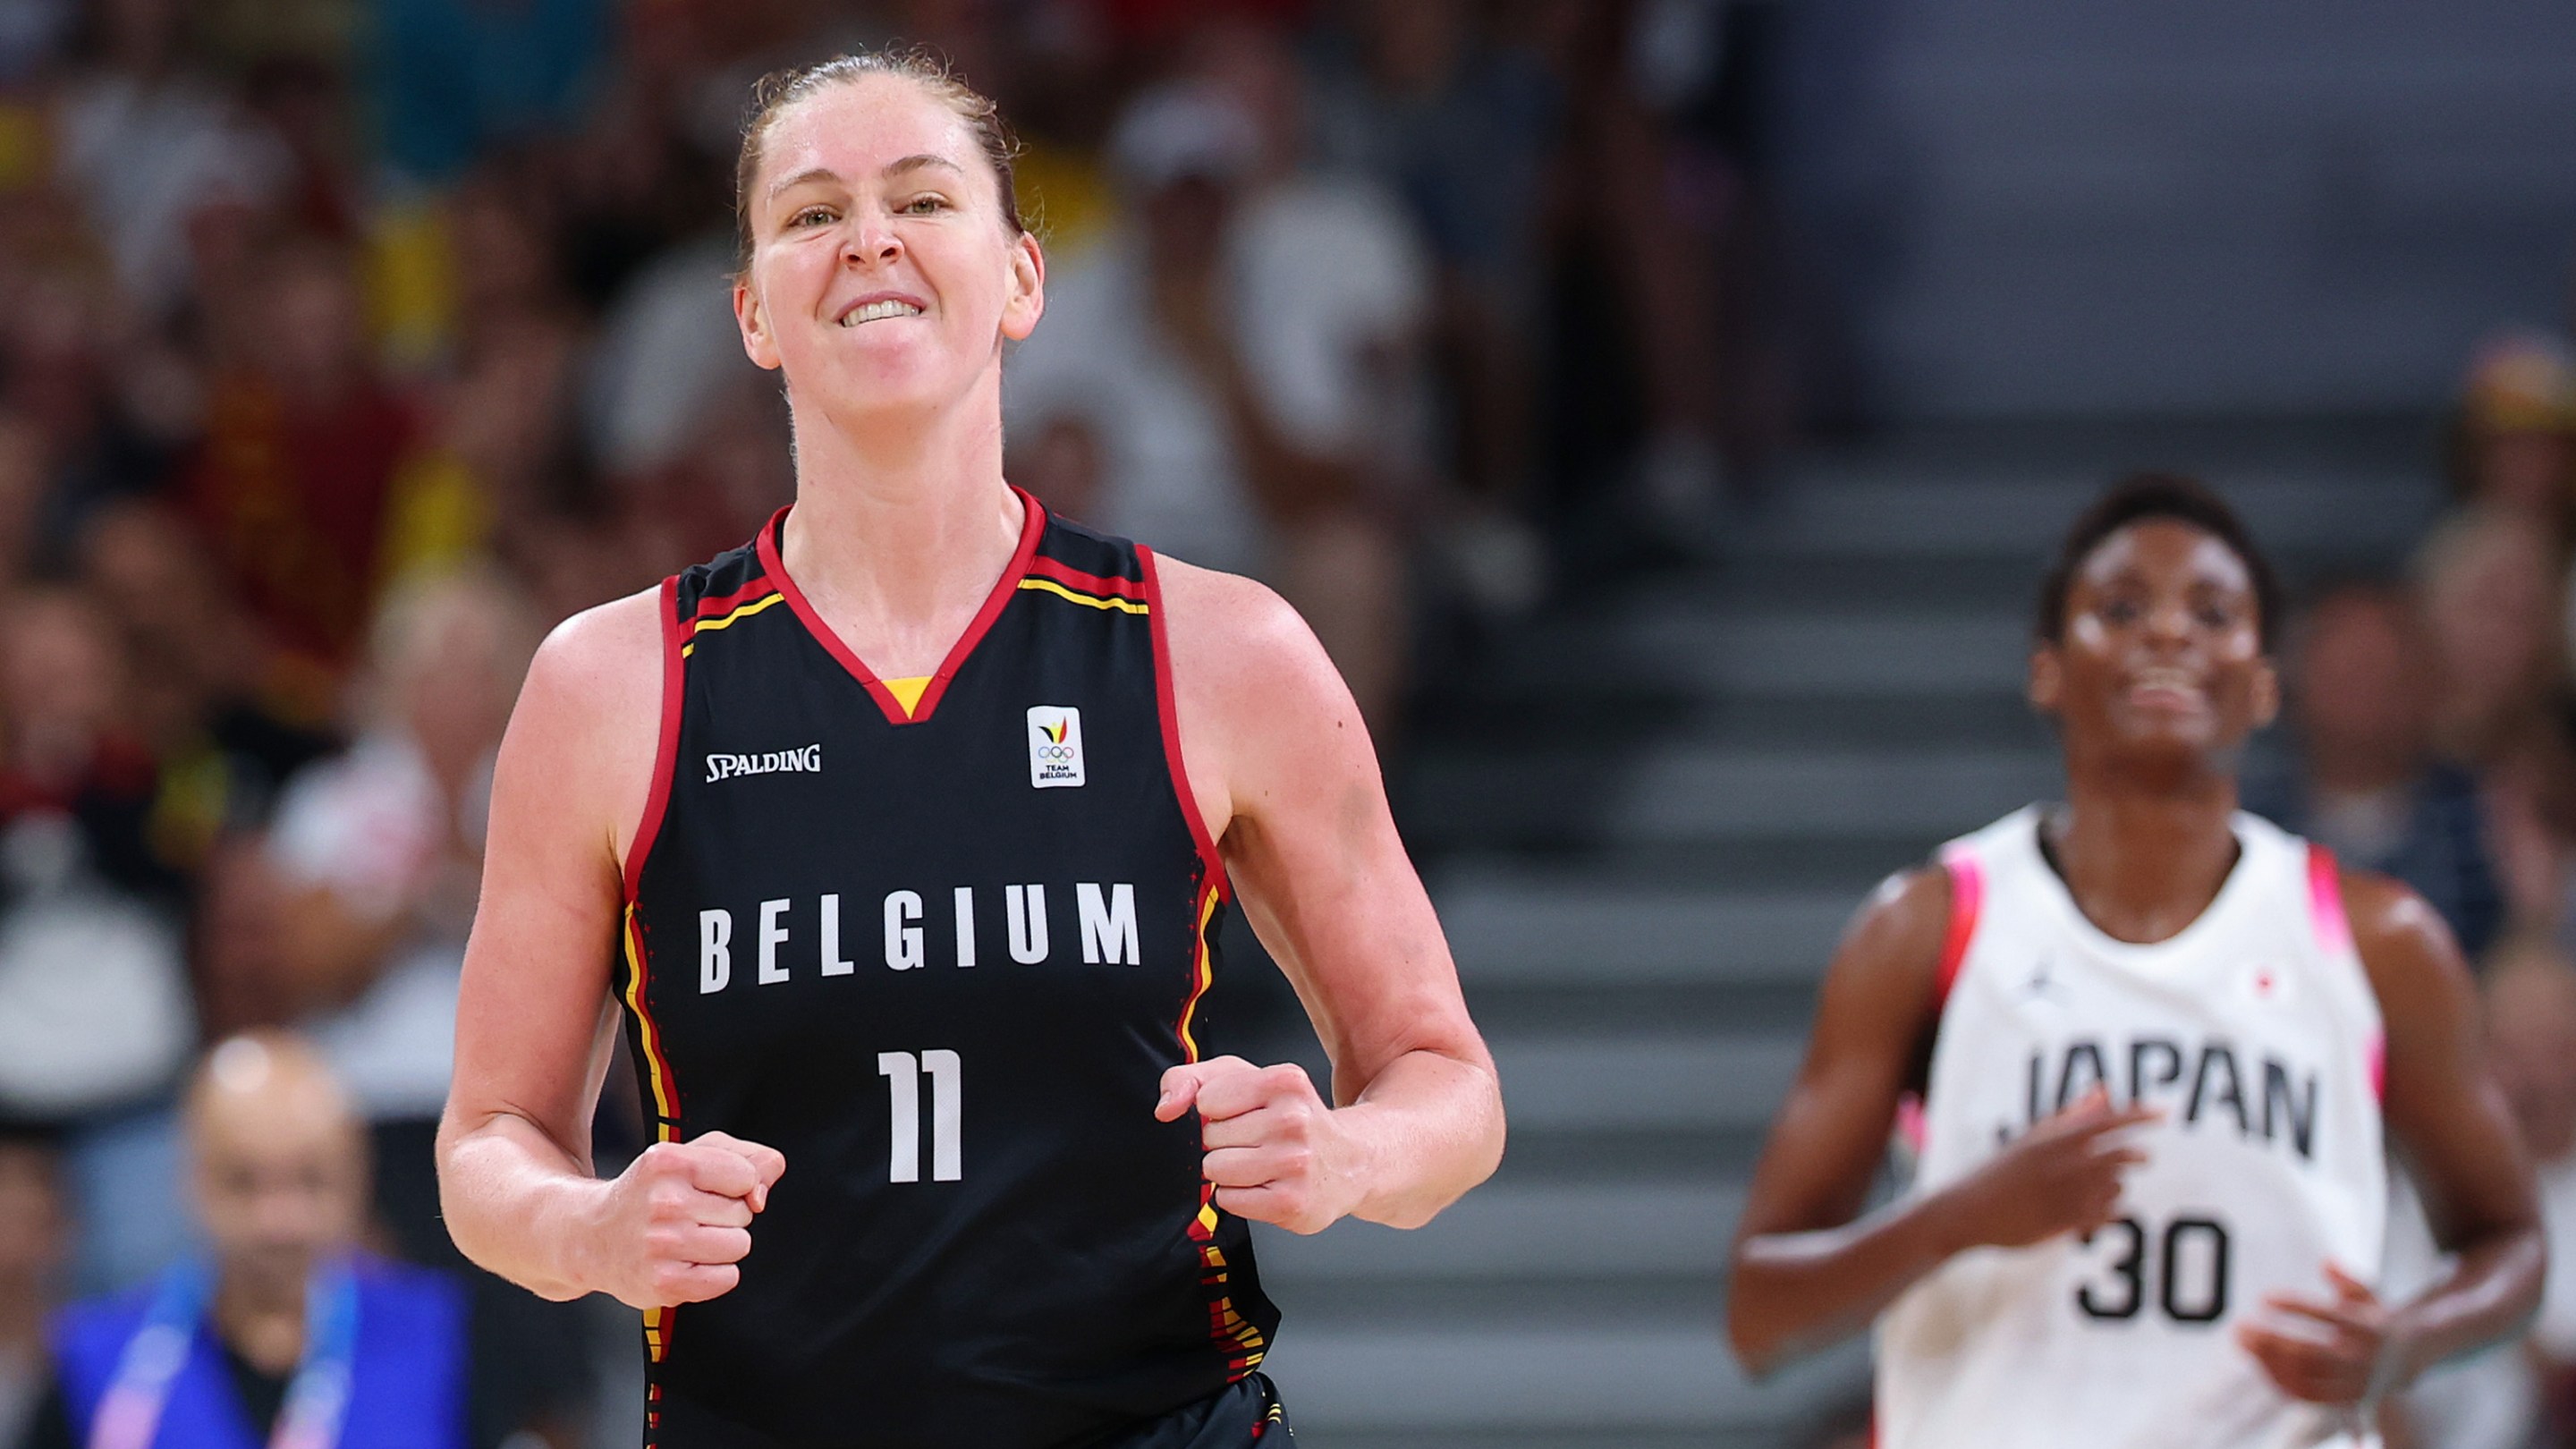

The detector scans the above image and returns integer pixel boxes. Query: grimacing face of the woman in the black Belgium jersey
[734,75,1046,420]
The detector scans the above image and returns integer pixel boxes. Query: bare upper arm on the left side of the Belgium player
[448,580,665,1160]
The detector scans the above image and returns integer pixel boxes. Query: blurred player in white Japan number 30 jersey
[1728,477,2543,1449]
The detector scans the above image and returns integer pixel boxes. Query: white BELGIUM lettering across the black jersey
[698,882,1144,996]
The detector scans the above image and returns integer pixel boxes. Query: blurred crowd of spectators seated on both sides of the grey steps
[0,0,2576,1449]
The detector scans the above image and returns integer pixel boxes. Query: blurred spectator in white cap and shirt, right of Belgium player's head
[1004,80,1411,740]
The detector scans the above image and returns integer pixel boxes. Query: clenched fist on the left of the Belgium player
[588,1131,788,1307]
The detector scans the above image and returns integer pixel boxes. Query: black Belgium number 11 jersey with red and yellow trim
[615,495,1277,1449]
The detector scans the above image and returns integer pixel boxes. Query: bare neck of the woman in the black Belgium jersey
[781,381,1022,678]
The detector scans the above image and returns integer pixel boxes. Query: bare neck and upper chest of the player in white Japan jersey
[2040,768,2239,944]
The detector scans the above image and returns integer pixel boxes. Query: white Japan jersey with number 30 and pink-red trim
[1878,807,2388,1449]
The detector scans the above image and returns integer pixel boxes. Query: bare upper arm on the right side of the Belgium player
[1159,560,1492,1104]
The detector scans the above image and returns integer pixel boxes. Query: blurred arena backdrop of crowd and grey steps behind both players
[0,0,2576,1449]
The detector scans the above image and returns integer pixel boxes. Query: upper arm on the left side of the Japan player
[1736,867,1950,1241]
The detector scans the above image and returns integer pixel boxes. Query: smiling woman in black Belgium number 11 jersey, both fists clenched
[440,56,1502,1449]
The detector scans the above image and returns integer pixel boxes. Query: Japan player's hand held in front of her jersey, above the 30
[1943,1088,2164,1248]
